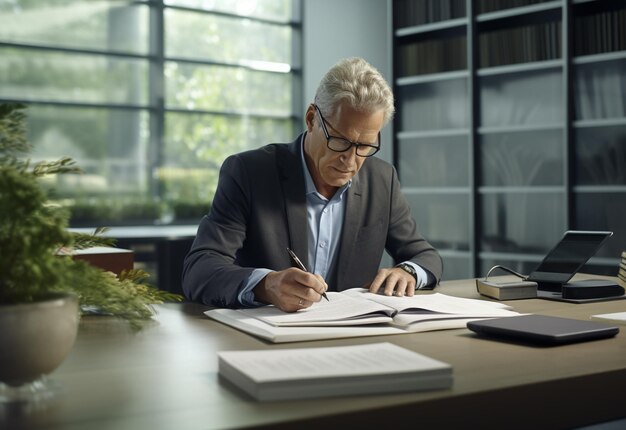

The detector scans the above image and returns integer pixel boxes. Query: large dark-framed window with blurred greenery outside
[0,0,301,226]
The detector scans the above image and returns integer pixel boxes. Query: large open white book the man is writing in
[205,288,519,343]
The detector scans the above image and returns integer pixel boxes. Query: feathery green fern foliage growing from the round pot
[0,104,182,328]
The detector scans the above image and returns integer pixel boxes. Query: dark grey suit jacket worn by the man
[183,136,442,308]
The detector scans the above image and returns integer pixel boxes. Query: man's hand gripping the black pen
[253,268,328,312]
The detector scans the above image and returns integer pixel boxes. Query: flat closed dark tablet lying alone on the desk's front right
[467,315,619,345]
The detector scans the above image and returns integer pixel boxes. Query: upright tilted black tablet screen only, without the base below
[526,230,613,290]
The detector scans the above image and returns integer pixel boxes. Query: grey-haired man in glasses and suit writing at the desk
[183,58,442,312]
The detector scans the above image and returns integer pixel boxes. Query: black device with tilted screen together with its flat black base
[526,230,624,302]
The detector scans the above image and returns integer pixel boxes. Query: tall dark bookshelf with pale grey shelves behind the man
[391,0,626,279]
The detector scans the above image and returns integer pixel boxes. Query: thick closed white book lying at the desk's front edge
[218,342,453,401]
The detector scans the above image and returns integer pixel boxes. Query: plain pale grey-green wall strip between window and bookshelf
[302,0,393,161]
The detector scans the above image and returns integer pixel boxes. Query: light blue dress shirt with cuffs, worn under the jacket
[237,134,428,307]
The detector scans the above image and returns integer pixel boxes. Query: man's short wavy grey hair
[315,57,395,125]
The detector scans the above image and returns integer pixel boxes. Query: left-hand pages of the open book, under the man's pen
[236,292,395,326]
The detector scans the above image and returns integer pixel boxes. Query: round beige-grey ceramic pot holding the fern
[0,294,79,387]
